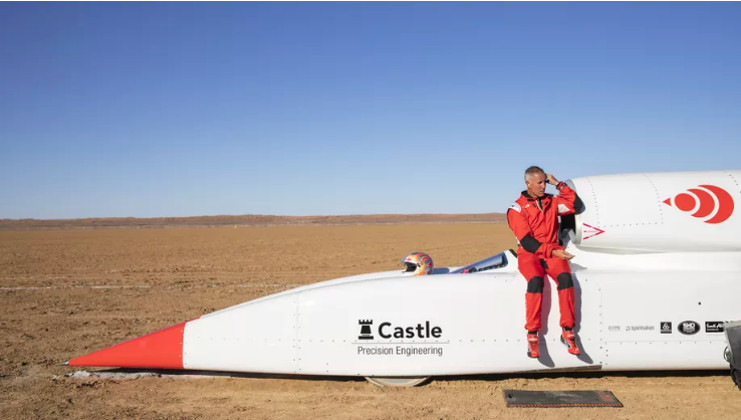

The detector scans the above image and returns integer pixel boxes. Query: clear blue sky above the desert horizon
[0,3,741,219]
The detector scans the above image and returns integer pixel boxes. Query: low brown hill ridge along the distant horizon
[0,213,505,230]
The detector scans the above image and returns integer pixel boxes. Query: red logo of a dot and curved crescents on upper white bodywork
[664,185,733,224]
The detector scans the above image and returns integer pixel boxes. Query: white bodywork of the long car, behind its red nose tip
[70,171,741,377]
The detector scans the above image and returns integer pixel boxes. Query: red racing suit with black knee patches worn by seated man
[507,182,577,332]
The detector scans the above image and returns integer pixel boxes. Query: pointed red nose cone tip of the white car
[68,322,186,369]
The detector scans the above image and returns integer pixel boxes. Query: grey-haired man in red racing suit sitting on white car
[507,166,581,358]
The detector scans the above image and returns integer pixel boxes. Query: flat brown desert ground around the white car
[0,222,741,419]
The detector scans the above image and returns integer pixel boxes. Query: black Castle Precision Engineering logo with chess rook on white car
[353,318,449,357]
